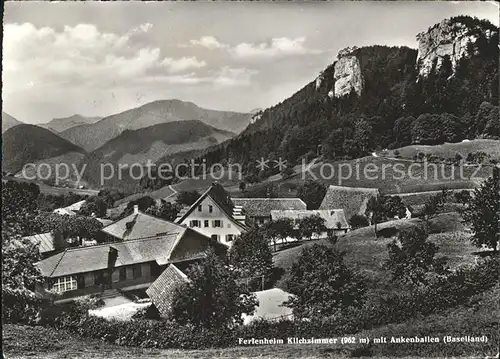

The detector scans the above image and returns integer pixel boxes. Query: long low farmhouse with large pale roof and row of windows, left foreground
[36,212,226,299]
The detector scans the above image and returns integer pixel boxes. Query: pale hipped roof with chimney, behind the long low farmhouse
[101,212,186,240]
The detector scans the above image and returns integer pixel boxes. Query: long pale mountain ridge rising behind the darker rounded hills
[60,100,251,152]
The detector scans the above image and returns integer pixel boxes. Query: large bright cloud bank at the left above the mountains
[3,23,207,94]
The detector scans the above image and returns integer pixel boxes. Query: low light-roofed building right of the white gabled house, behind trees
[271,209,351,238]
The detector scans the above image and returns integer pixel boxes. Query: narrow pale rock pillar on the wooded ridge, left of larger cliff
[334,51,364,98]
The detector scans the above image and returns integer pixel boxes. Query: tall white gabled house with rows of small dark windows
[175,183,247,246]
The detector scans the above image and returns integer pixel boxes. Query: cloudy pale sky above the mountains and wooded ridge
[2,1,499,124]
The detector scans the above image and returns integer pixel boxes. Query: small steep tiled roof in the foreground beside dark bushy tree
[146,264,189,316]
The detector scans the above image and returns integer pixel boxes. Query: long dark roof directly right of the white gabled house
[233,198,307,217]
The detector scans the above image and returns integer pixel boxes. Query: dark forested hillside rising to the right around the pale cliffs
[178,17,500,180]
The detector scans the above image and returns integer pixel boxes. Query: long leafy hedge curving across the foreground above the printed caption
[4,259,500,349]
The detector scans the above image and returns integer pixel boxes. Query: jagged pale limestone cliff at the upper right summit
[417,19,492,77]
